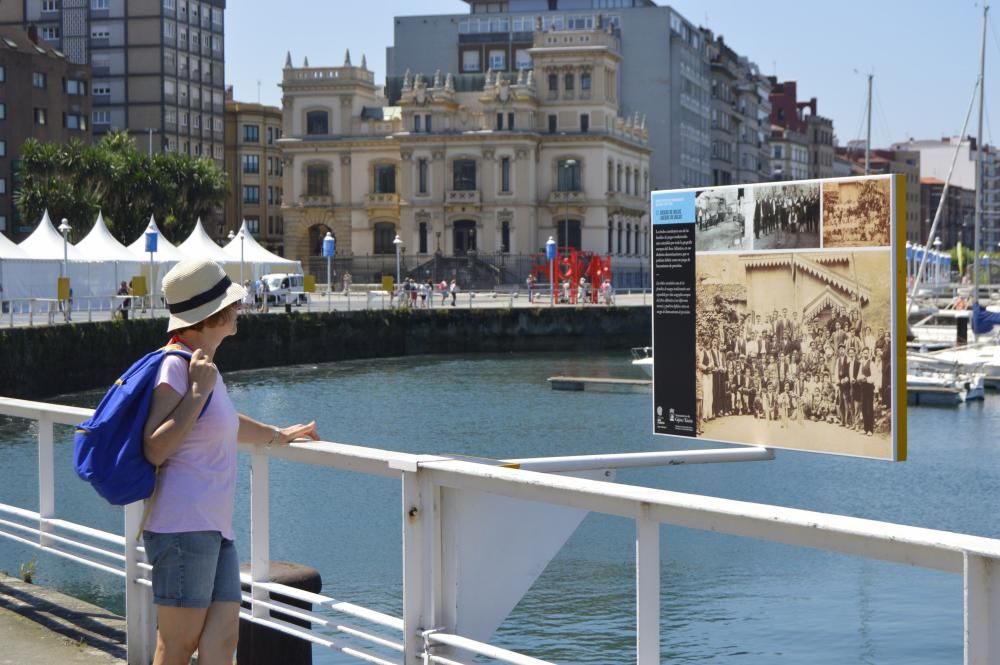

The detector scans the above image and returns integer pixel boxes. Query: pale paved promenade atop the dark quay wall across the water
[0,291,652,328]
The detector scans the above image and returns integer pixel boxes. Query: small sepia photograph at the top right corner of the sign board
[823,177,892,248]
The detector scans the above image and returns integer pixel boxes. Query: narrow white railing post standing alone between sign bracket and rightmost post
[635,504,660,665]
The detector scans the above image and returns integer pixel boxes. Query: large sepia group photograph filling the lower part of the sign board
[696,249,893,459]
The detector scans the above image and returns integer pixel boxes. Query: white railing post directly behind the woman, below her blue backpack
[125,501,156,665]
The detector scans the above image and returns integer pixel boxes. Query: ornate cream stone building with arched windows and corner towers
[280,28,650,286]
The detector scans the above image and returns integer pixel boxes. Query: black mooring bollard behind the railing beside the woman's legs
[236,561,323,665]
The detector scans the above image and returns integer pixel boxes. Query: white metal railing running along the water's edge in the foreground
[0,398,1000,665]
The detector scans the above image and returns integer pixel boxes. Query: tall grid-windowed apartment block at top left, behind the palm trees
[0,0,226,165]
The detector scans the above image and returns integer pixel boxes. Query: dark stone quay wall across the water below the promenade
[0,307,652,399]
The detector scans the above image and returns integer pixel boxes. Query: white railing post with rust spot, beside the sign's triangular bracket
[402,470,441,665]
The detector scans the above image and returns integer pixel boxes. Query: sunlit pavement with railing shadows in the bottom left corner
[0,574,125,665]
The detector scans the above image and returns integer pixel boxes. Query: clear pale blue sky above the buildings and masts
[226,0,1000,146]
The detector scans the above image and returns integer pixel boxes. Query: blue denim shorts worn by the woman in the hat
[142,531,240,608]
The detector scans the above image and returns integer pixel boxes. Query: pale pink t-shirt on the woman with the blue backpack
[146,356,239,540]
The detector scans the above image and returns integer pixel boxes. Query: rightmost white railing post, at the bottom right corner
[965,553,1000,665]
